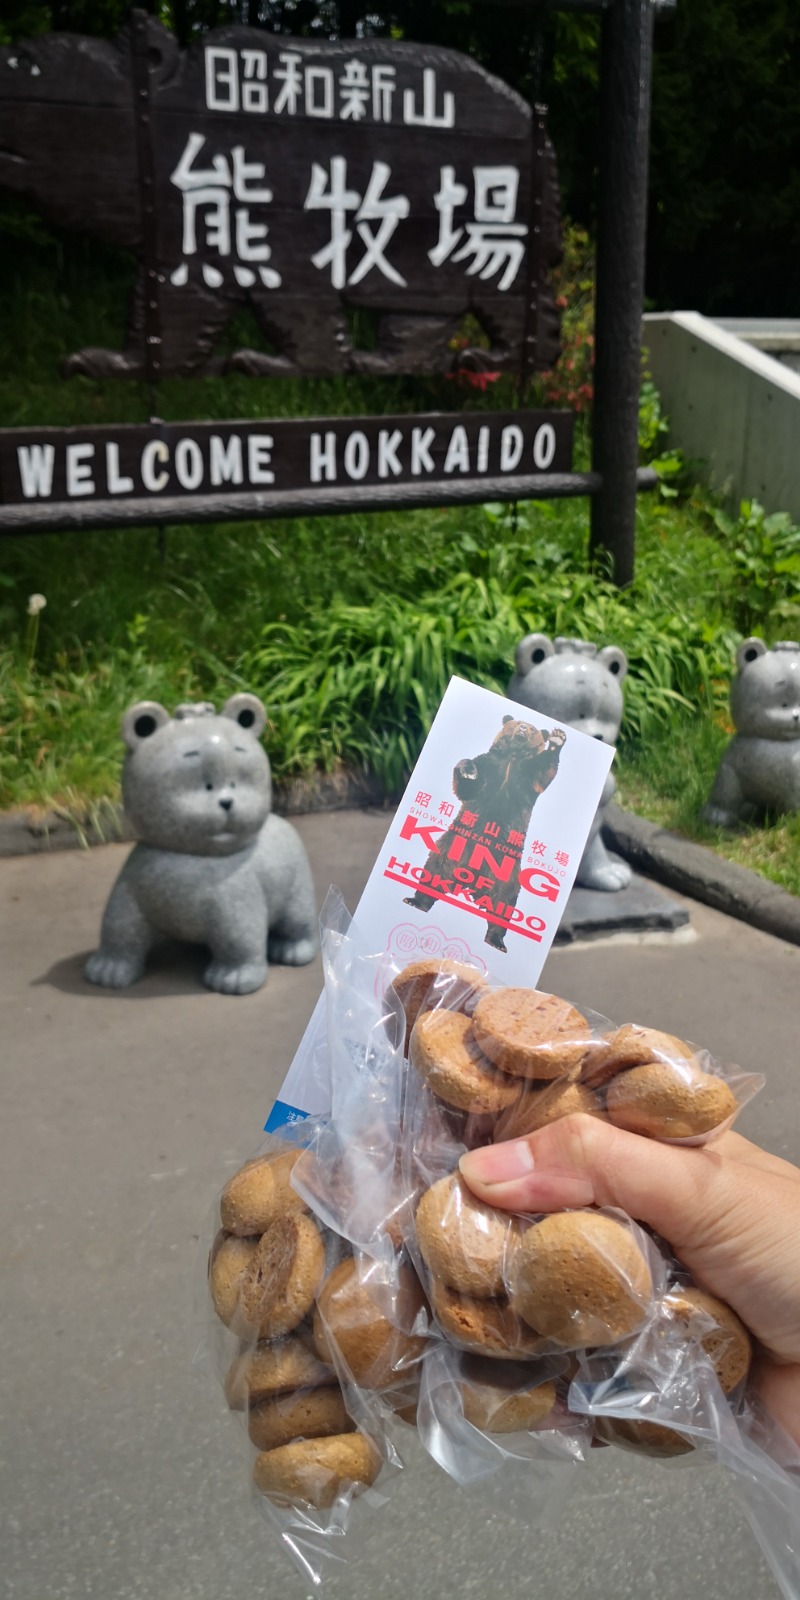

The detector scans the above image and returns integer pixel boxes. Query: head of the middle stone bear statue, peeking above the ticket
[507,634,627,744]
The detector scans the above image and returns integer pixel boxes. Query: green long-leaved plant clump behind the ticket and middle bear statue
[237,507,736,790]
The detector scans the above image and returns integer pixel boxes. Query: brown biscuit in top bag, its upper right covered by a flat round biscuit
[408,1011,522,1114]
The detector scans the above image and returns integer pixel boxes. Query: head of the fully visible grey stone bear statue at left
[122,694,272,856]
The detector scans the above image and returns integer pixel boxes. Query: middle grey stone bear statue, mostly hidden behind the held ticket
[507,634,632,890]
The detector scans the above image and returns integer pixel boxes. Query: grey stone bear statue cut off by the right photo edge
[701,638,800,827]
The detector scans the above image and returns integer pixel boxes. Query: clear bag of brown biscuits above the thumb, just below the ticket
[390,962,763,1144]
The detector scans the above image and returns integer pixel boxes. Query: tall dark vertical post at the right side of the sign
[589,0,654,584]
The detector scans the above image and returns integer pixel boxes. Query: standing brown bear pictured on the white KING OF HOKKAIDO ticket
[405,715,566,950]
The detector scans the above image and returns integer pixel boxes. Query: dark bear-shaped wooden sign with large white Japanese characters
[0,11,558,379]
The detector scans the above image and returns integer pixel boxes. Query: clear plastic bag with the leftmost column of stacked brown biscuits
[208,1123,398,1582]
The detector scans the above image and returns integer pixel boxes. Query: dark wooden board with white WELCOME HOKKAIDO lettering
[0,411,574,531]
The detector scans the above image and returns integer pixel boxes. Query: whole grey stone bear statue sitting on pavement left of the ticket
[85,694,317,995]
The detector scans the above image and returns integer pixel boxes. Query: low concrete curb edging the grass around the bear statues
[0,787,800,944]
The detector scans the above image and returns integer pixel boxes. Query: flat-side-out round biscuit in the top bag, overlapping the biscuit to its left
[472,989,590,1078]
